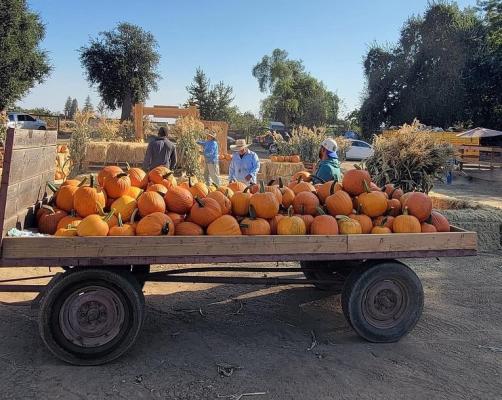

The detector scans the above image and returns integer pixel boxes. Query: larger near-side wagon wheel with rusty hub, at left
[39,269,145,365]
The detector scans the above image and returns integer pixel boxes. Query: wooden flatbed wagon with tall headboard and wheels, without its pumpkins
[0,129,477,365]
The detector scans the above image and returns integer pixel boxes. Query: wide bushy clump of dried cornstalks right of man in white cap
[366,120,455,193]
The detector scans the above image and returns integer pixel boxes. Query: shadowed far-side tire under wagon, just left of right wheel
[300,261,354,293]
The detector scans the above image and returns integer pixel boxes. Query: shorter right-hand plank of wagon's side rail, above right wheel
[347,232,477,253]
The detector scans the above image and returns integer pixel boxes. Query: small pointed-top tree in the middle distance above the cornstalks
[186,68,234,121]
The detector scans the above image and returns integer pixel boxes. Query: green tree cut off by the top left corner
[0,0,51,111]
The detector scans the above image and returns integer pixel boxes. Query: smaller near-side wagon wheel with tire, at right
[342,261,424,343]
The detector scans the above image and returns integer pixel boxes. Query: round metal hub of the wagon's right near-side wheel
[362,279,408,328]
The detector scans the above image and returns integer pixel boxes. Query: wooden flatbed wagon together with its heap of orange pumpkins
[0,129,477,365]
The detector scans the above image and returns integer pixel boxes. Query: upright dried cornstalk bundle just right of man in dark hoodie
[171,117,204,178]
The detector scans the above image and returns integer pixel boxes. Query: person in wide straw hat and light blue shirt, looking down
[228,139,260,185]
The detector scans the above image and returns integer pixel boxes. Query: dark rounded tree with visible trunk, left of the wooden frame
[80,23,160,121]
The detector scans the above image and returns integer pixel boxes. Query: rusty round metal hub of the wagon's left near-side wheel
[59,286,124,347]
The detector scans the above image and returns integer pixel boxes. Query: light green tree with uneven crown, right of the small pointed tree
[252,49,340,126]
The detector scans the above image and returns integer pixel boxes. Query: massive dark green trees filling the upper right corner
[360,1,502,134]
